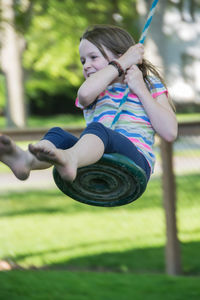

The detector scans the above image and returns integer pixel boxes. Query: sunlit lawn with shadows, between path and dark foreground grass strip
[0,175,200,274]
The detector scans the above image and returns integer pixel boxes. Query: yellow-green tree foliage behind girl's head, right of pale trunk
[24,0,138,89]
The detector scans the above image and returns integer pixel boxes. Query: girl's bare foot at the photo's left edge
[0,135,31,180]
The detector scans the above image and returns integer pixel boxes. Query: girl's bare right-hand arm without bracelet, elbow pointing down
[125,65,178,142]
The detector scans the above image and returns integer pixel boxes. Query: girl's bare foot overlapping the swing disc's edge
[29,140,77,182]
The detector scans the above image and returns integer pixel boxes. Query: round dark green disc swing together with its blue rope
[53,0,158,207]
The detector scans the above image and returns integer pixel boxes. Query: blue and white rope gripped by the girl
[110,0,158,128]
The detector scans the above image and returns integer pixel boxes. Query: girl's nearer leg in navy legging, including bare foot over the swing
[31,122,150,181]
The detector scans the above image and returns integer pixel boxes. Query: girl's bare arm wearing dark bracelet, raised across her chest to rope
[78,44,144,107]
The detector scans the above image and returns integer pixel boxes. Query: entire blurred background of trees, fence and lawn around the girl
[0,0,200,300]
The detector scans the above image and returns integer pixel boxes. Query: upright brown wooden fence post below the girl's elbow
[161,139,181,275]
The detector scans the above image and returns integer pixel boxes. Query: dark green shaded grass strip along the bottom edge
[0,271,200,300]
